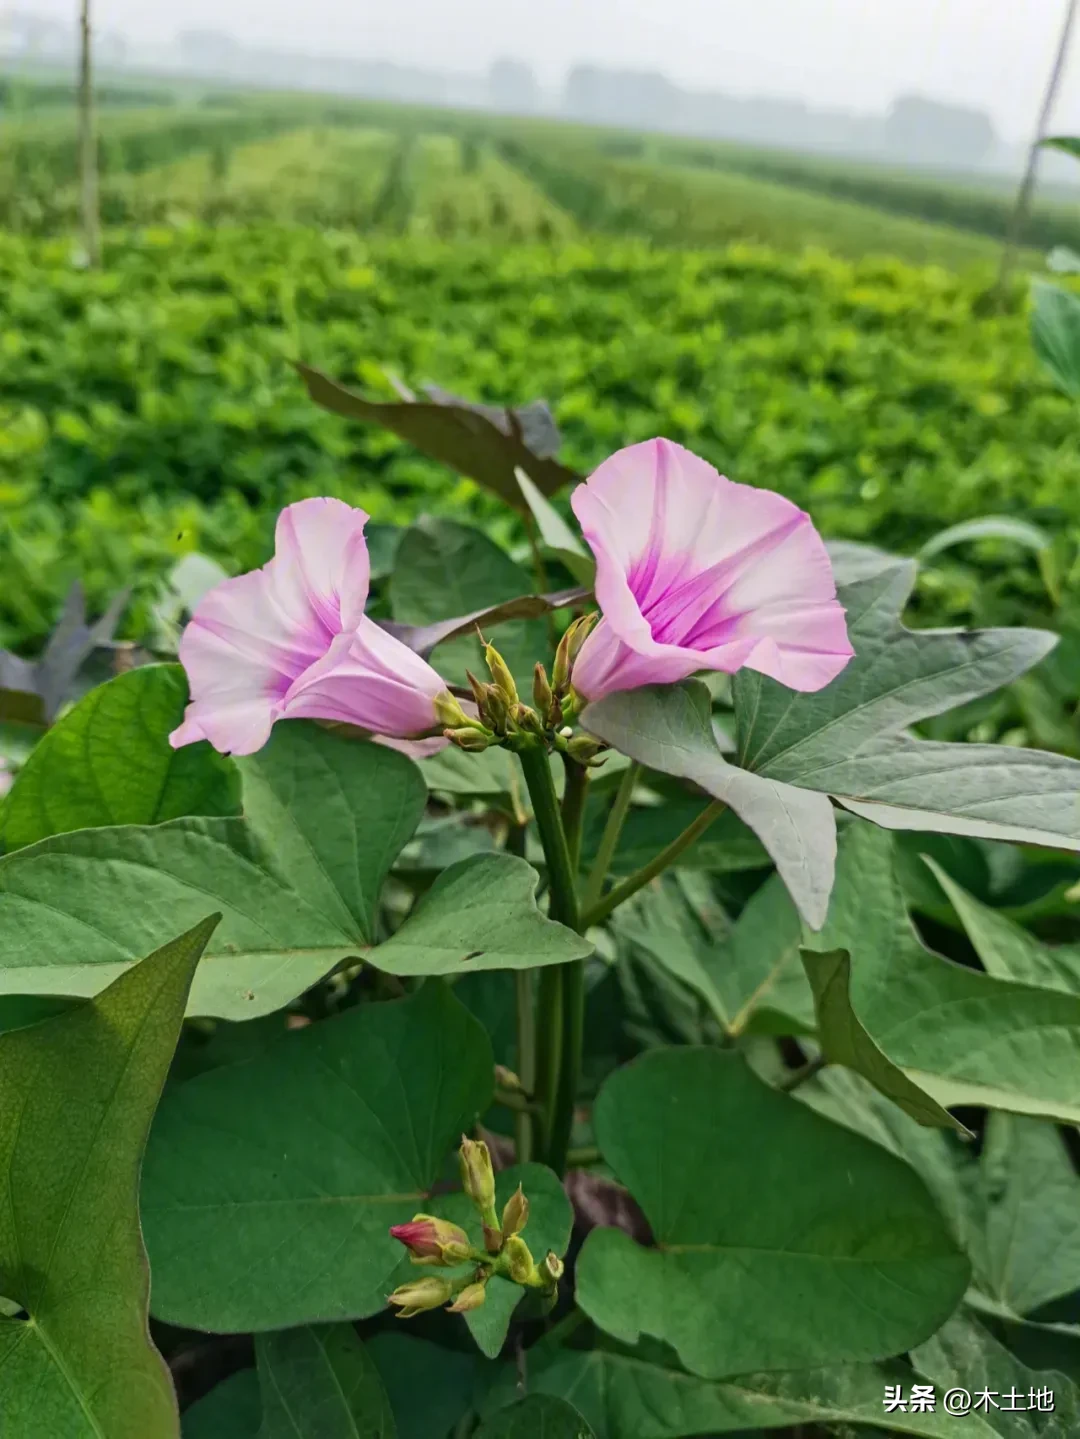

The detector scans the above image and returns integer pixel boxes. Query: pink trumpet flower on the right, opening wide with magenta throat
[571,439,853,699]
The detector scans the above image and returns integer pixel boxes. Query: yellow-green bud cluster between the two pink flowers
[439,613,604,764]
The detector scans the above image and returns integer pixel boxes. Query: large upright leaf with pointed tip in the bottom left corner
[0,917,217,1439]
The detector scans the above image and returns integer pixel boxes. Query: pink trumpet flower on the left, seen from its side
[170,499,446,754]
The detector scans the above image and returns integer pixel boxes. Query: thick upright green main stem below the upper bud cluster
[518,745,585,1174]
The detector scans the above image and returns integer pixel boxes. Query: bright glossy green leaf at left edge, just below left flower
[0,665,240,852]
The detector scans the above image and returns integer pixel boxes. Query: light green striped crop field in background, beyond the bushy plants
[0,95,1064,266]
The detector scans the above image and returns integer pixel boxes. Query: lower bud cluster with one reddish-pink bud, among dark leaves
[388,1135,562,1320]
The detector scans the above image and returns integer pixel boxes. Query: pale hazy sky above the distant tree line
[27,0,1080,140]
